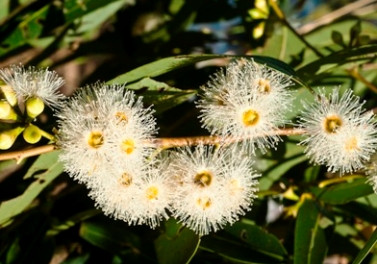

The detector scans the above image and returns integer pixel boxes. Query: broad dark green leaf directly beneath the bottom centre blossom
[154,219,200,264]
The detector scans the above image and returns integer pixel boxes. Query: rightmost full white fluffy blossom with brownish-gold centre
[300,89,377,174]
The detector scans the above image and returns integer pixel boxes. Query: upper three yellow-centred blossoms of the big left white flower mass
[57,83,156,186]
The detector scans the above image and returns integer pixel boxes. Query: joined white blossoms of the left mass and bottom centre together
[57,84,258,235]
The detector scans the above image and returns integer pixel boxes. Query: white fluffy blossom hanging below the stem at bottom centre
[168,145,259,235]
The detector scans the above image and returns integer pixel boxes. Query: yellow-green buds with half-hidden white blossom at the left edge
[0,65,64,150]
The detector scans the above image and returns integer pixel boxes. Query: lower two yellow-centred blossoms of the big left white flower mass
[89,162,174,228]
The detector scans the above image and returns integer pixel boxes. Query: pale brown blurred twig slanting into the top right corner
[297,0,376,35]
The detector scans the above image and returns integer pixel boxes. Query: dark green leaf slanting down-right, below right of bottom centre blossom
[226,219,288,261]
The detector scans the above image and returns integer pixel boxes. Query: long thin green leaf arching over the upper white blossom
[108,54,304,87]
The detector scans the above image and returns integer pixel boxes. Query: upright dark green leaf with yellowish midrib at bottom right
[293,199,327,264]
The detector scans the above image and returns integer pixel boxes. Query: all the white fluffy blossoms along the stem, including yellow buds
[0,59,377,235]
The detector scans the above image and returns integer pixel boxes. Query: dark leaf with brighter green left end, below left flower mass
[79,221,140,253]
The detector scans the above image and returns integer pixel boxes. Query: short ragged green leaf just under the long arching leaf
[126,78,197,113]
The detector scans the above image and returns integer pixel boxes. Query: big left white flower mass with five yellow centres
[57,83,171,228]
